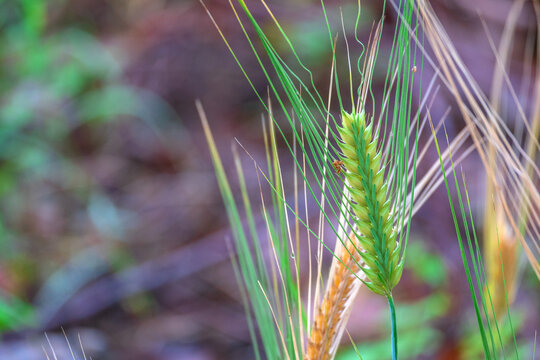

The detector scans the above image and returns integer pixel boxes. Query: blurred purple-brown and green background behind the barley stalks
[0,0,540,360]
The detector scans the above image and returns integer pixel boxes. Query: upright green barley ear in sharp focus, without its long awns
[338,111,403,296]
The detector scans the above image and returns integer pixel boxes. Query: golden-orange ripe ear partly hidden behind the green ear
[304,235,361,360]
